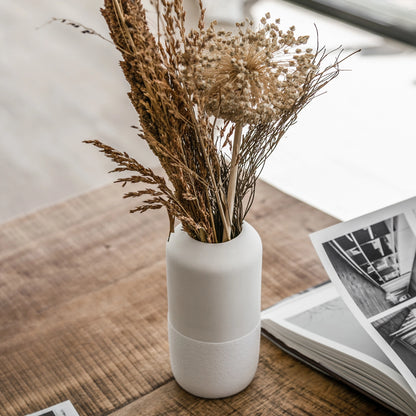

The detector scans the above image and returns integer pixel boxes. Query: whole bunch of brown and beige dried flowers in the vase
[86,0,354,243]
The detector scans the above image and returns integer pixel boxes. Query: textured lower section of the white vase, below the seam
[168,322,260,399]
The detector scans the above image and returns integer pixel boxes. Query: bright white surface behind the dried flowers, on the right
[252,1,416,220]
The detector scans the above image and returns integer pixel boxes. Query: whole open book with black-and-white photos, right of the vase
[262,198,416,416]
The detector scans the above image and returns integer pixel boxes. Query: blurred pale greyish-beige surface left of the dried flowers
[0,0,161,223]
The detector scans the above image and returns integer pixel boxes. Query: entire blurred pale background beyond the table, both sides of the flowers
[0,0,416,222]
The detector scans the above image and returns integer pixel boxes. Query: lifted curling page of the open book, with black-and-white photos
[311,198,416,393]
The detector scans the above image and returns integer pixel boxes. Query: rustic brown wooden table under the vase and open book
[0,183,391,416]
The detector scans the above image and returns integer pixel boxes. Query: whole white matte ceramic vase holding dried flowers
[166,223,262,398]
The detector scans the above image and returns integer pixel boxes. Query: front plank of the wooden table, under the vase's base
[111,338,391,416]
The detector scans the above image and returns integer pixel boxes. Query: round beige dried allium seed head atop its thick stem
[182,14,314,124]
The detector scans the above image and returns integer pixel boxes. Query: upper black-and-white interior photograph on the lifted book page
[323,211,416,318]
